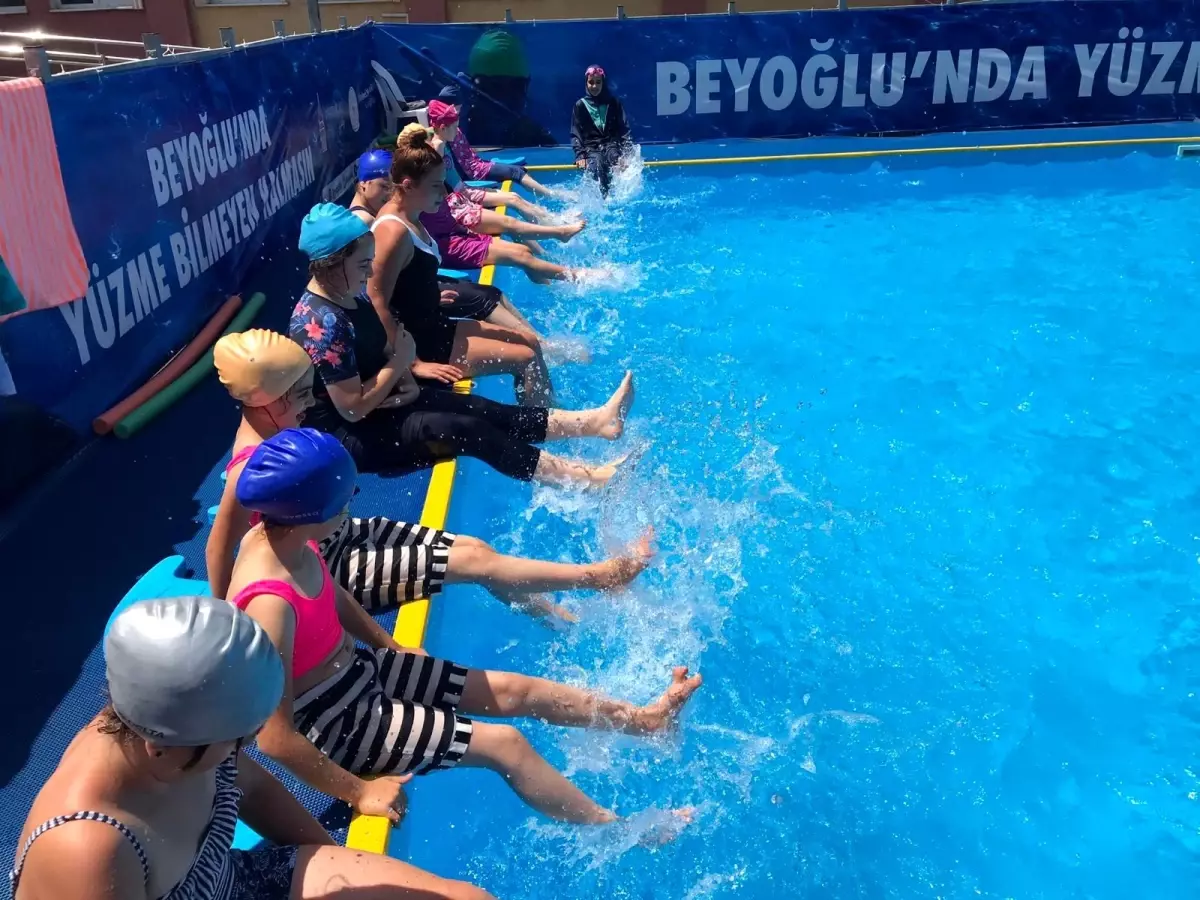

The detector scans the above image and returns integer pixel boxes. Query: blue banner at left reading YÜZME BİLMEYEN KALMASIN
[0,28,378,428]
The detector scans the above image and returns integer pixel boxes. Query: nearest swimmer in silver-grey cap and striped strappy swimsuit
[10,596,492,900]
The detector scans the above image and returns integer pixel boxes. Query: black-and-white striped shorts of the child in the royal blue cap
[293,647,472,775]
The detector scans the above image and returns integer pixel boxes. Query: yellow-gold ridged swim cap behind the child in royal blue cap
[212,328,312,407]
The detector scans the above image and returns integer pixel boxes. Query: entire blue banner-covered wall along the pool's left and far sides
[0,0,1200,434]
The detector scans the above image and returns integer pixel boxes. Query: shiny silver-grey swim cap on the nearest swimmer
[104,596,283,746]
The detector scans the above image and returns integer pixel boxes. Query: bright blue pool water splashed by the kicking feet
[394,151,1200,900]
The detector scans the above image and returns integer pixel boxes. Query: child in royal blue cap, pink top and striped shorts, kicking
[229,428,701,824]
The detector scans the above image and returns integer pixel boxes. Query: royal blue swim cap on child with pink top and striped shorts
[238,428,359,526]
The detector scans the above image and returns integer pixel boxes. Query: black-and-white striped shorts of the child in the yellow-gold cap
[320,516,455,612]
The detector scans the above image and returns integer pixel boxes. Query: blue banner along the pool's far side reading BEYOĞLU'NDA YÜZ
[374,0,1200,146]
